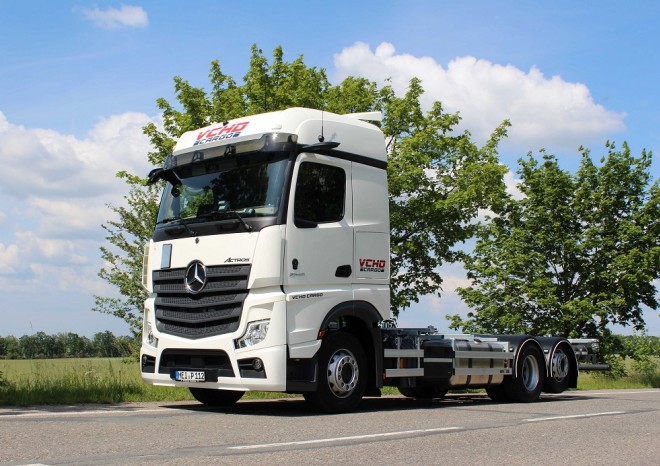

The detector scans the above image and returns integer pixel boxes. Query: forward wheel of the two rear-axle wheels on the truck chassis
[502,345,545,403]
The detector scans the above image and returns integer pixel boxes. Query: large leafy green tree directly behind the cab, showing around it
[95,46,508,333]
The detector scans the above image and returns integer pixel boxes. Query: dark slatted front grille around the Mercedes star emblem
[153,265,250,339]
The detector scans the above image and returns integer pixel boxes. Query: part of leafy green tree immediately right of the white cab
[381,79,509,315]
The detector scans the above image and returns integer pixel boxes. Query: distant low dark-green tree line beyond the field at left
[0,330,137,359]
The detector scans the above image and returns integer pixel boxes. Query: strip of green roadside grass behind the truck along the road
[0,358,660,406]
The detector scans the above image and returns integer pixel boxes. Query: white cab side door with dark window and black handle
[283,154,355,344]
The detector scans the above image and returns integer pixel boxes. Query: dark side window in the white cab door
[294,162,346,228]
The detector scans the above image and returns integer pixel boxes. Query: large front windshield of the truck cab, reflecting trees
[157,153,288,225]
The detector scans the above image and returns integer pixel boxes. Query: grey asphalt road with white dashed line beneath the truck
[0,390,660,465]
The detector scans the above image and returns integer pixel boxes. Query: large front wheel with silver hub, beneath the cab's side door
[304,332,368,413]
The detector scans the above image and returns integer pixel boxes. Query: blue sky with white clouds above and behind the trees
[0,0,660,336]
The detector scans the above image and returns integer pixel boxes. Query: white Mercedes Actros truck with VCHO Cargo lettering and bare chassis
[141,108,604,412]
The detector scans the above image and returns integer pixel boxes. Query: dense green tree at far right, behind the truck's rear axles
[450,142,660,342]
